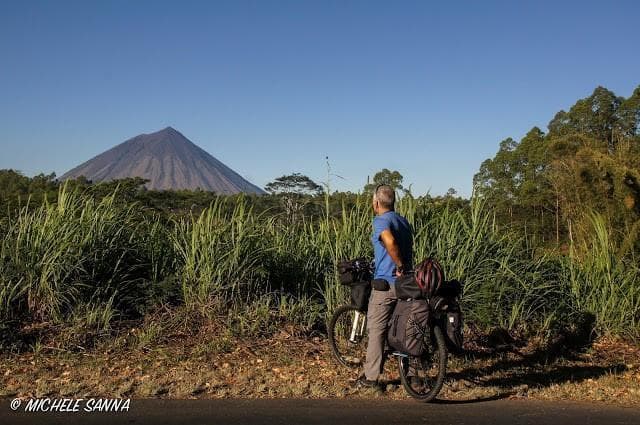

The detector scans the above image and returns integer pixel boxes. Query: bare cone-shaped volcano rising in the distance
[60,127,264,194]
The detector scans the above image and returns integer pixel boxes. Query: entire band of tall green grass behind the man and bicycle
[0,186,640,346]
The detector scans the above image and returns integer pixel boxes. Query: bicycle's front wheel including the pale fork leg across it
[328,305,368,368]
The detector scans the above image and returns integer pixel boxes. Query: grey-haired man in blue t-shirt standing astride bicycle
[357,185,413,388]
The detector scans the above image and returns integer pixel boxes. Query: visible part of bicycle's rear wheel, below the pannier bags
[398,326,447,402]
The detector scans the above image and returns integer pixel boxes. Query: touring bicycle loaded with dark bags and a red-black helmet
[328,258,462,402]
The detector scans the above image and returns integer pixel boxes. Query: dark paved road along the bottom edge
[0,399,640,425]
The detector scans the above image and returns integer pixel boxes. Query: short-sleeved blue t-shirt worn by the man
[371,211,413,283]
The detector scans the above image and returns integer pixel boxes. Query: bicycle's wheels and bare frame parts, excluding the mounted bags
[328,274,448,402]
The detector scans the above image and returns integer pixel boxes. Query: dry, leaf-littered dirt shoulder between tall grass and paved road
[0,329,640,406]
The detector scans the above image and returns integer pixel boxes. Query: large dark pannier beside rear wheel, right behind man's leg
[387,299,429,356]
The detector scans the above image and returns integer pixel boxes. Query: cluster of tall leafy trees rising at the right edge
[474,87,640,247]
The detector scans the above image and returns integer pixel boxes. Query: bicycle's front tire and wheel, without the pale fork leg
[328,305,367,368]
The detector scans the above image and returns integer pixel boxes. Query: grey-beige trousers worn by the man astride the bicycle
[364,285,398,381]
